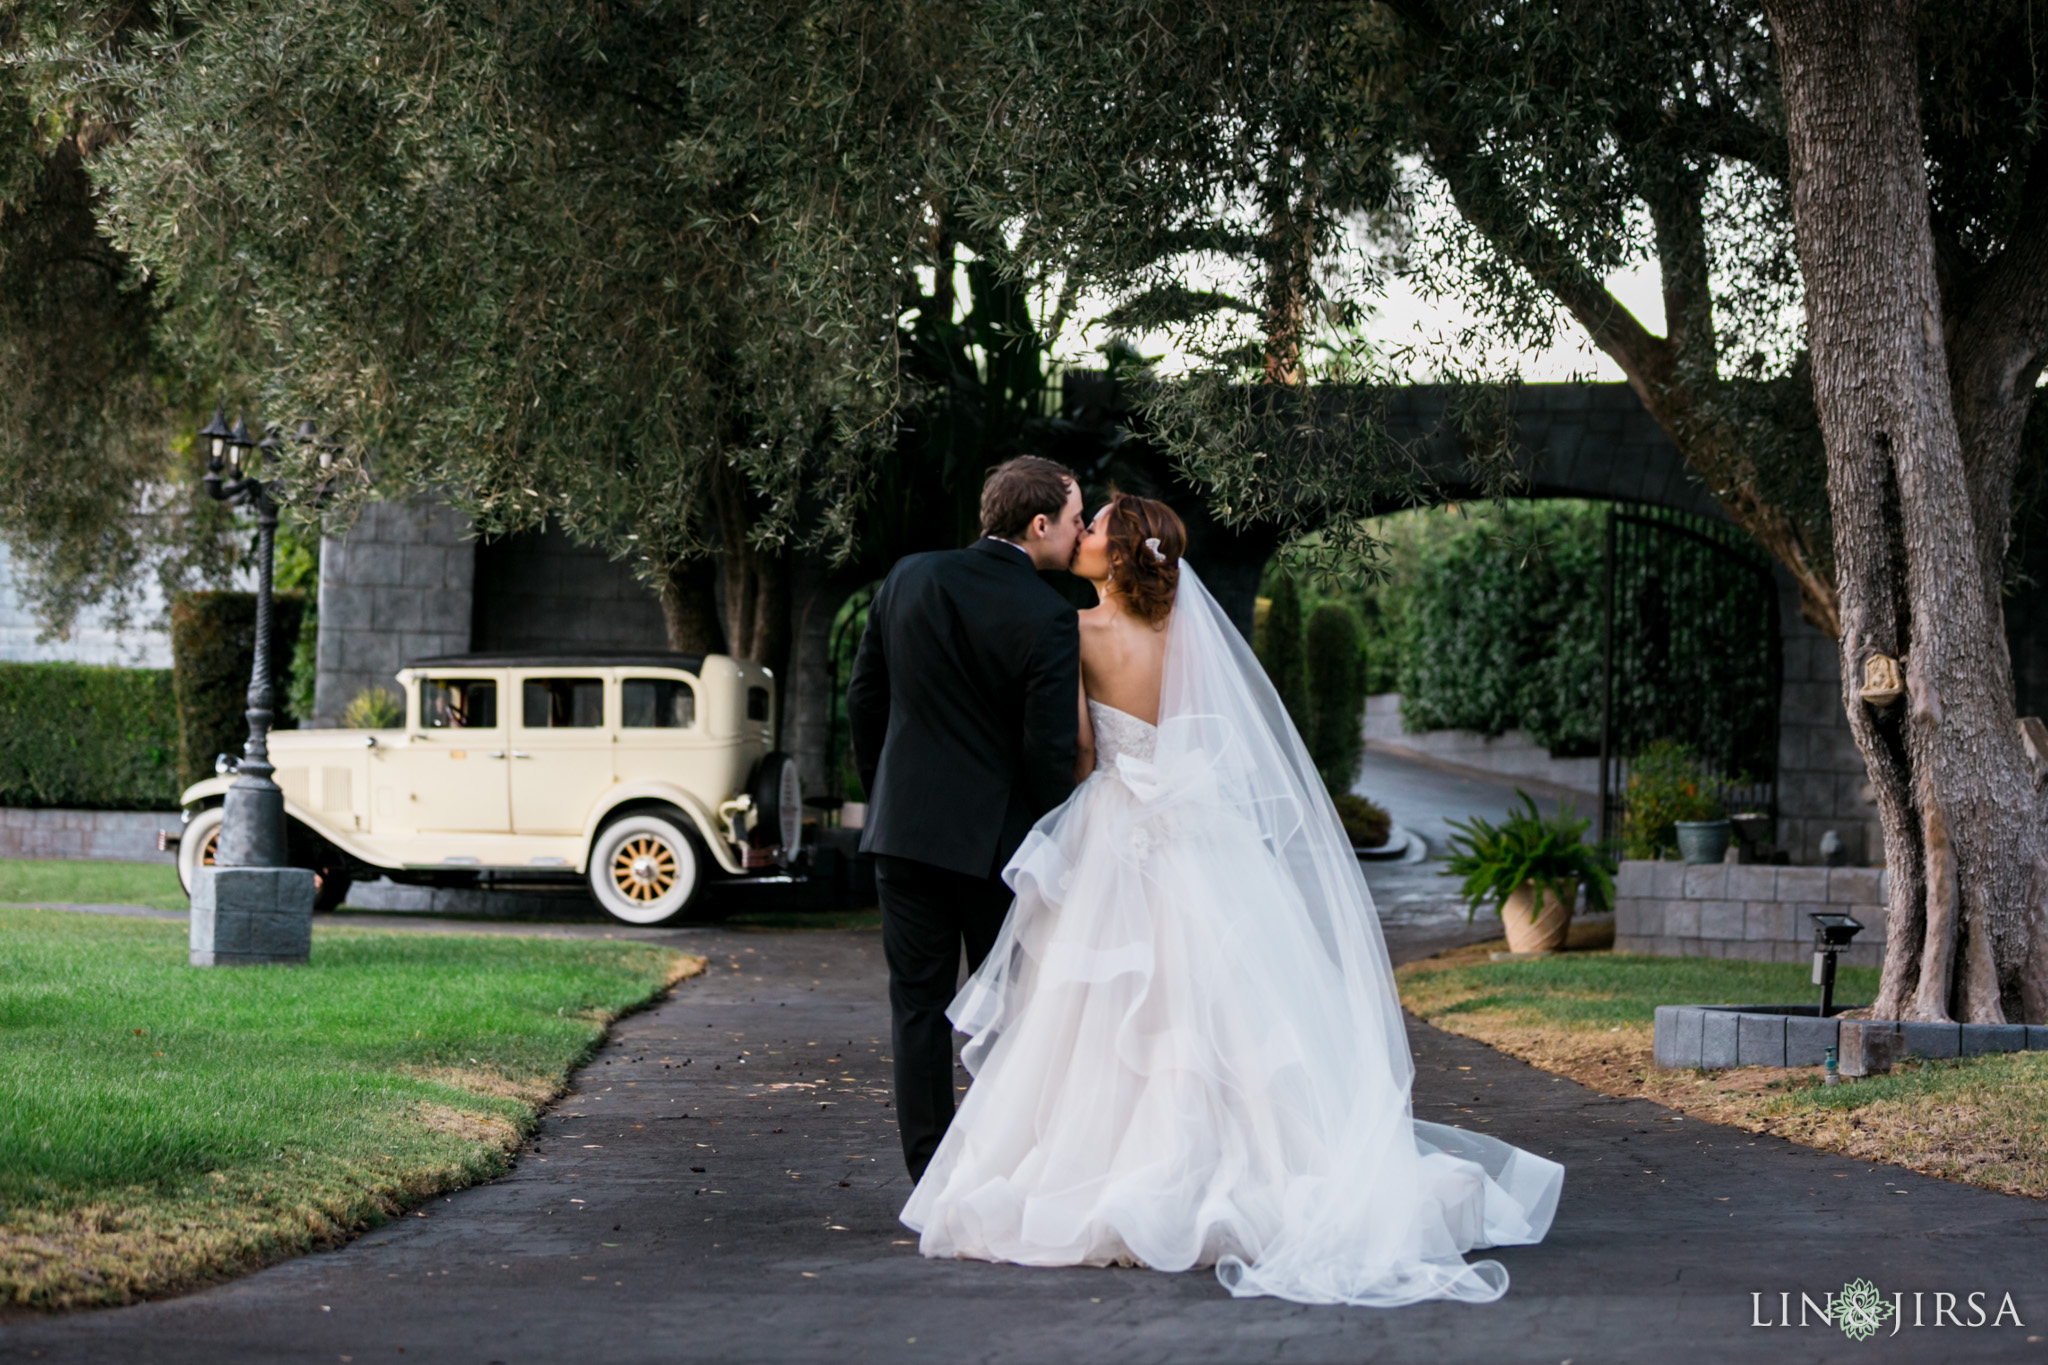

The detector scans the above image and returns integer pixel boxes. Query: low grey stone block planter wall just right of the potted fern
[1614,862,1886,966]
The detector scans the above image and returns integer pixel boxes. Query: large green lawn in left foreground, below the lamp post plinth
[0,908,702,1308]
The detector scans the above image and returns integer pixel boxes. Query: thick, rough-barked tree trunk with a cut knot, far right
[1763,0,2048,1023]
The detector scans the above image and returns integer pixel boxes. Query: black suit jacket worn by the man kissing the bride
[846,540,1081,876]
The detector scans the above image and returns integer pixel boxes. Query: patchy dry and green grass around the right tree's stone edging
[1397,941,2048,1199]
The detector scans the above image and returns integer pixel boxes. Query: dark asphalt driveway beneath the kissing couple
[0,917,2048,1365]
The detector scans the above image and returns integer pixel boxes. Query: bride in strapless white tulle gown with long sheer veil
[903,495,1565,1308]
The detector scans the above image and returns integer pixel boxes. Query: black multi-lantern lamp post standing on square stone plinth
[199,407,289,868]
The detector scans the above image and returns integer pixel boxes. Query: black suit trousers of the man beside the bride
[874,853,1012,1181]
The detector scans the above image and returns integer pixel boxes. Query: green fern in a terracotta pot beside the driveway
[1444,790,1614,954]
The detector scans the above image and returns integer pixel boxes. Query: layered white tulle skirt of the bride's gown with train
[903,757,1563,1306]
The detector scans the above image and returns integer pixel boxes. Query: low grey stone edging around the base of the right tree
[1653,1005,2048,1074]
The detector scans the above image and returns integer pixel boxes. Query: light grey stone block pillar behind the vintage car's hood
[309,499,477,726]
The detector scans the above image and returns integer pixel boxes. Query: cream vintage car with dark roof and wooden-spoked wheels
[176,653,803,925]
